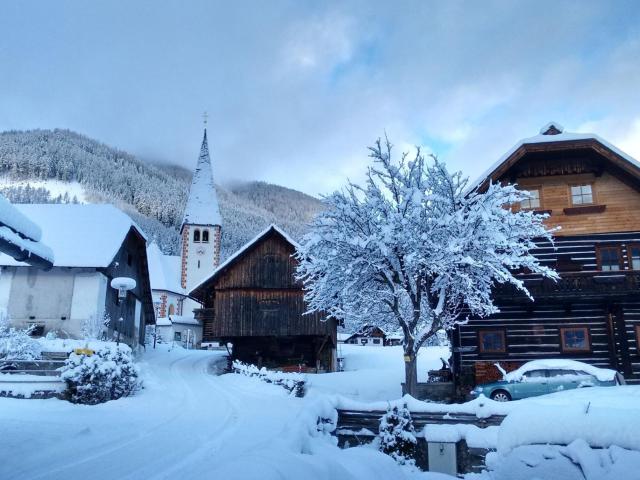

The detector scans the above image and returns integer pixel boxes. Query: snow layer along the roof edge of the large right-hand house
[467,122,640,192]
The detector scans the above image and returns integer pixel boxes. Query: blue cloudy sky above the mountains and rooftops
[0,0,640,194]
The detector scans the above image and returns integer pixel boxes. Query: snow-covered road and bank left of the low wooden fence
[0,348,437,480]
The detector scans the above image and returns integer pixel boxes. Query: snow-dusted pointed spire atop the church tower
[182,130,222,231]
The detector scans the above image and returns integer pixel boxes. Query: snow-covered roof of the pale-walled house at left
[0,204,144,267]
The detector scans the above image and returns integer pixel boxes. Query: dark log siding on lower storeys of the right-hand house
[453,232,640,383]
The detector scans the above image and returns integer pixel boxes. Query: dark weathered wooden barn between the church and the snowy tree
[190,225,337,372]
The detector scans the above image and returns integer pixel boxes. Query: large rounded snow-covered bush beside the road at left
[60,345,141,405]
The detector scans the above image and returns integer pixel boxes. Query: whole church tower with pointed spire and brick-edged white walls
[180,125,222,291]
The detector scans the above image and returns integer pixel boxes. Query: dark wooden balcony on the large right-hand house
[495,271,640,303]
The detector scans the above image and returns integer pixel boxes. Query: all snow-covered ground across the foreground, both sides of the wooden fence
[0,346,640,480]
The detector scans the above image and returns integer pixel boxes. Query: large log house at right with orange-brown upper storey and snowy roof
[452,124,640,385]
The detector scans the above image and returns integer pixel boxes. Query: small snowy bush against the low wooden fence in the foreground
[378,404,417,465]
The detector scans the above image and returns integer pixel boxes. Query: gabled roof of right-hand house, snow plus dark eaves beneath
[467,122,640,192]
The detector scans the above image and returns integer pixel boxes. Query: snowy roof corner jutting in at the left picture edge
[0,195,53,268]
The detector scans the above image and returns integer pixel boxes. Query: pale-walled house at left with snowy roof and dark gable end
[0,204,154,346]
